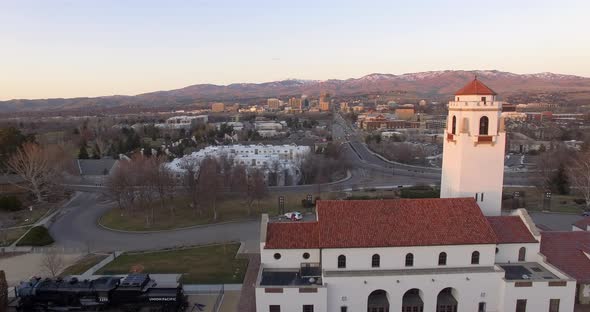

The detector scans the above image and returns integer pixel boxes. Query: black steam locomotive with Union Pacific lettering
[16,274,188,312]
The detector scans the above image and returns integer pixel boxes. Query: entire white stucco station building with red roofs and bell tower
[255,80,576,312]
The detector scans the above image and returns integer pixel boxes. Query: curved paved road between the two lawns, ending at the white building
[49,193,259,251]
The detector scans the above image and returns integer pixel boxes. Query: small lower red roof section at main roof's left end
[265,222,319,249]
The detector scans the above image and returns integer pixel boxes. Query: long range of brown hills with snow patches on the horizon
[0,70,590,113]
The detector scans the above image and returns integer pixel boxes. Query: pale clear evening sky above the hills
[0,0,590,100]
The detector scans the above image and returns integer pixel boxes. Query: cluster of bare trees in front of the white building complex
[107,154,268,226]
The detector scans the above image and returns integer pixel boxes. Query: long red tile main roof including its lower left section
[266,198,496,248]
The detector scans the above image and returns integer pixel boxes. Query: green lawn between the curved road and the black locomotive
[97,243,248,284]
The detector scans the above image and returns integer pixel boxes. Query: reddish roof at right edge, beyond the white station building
[541,231,590,283]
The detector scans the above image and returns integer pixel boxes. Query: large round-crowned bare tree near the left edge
[7,143,67,202]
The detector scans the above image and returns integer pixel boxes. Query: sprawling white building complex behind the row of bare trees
[168,144,311,185]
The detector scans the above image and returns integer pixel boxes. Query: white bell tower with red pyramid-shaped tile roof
[440,77,506,216]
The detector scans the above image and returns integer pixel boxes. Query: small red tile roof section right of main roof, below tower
[487,216,537,244]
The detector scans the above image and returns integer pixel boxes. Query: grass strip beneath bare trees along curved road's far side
[100,193,330,231]
